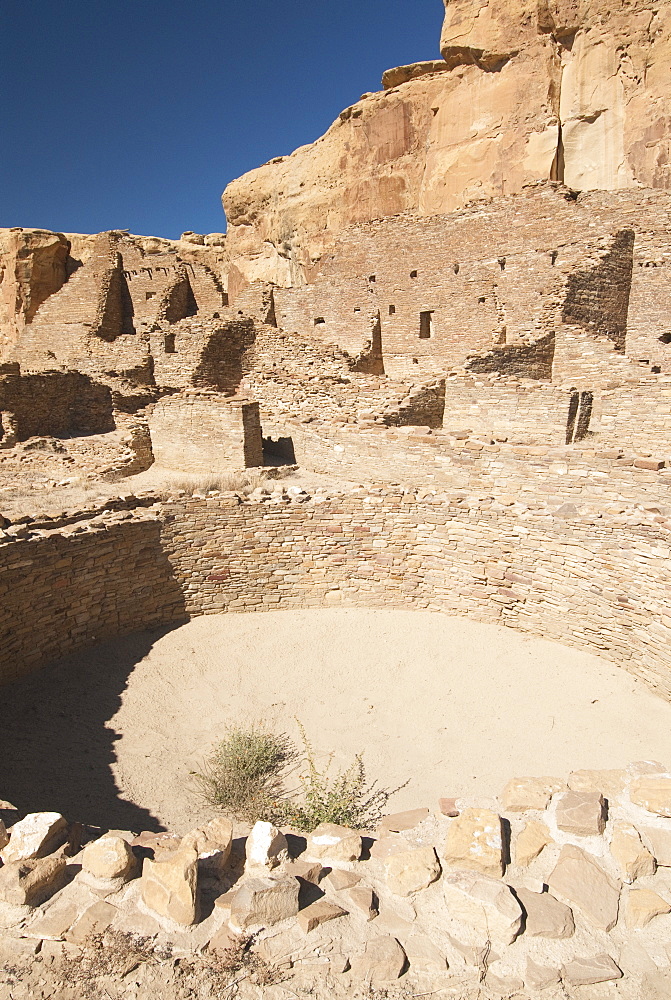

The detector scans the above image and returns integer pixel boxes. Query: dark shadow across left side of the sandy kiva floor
[0,622,183,832]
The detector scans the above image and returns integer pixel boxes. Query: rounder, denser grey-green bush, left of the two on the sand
[191,726,297,823]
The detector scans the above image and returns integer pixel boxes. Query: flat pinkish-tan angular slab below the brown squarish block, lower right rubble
[548,844,621,931]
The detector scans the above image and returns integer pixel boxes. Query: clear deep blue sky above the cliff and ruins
[0,0,443,238]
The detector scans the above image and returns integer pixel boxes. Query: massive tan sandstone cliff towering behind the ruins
[223,0,671,286]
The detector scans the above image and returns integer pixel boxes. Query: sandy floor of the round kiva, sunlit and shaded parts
[0,609,671,832]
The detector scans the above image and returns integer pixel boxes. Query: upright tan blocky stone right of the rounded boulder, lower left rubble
[142,847,198,926]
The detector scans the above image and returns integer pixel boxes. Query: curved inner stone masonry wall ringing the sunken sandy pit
[0,489,671,698]
